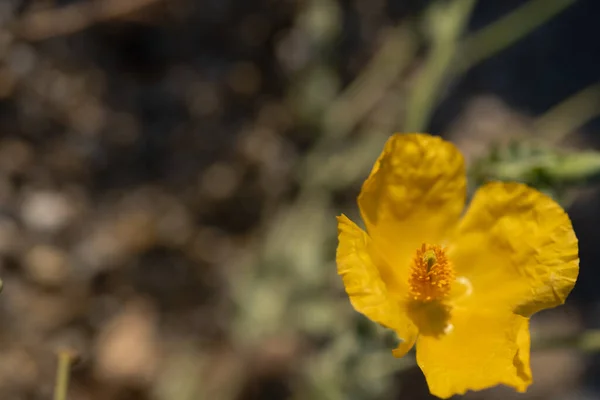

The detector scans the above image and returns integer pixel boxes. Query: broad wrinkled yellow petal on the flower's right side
[450,182,579,316]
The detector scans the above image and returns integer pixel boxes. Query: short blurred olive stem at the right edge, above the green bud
[534,82,600,144]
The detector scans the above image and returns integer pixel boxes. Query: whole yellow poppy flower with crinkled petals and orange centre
[337,134,579,398]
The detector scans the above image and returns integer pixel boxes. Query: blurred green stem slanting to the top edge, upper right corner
[455,0,576,74]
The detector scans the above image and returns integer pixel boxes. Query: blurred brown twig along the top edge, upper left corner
[14,0,166,41]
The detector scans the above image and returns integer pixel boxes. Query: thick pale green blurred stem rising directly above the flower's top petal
[404,0,475,132]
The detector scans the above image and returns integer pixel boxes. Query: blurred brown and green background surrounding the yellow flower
[0,0,600,400]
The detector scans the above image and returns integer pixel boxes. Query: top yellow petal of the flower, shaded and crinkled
[358,133,466,280]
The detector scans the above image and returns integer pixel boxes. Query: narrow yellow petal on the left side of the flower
[336,215,417,357]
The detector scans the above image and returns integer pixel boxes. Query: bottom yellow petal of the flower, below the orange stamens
[417,310,531,399]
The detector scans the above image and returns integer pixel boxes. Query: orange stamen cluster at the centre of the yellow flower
[408,243,454,302]
